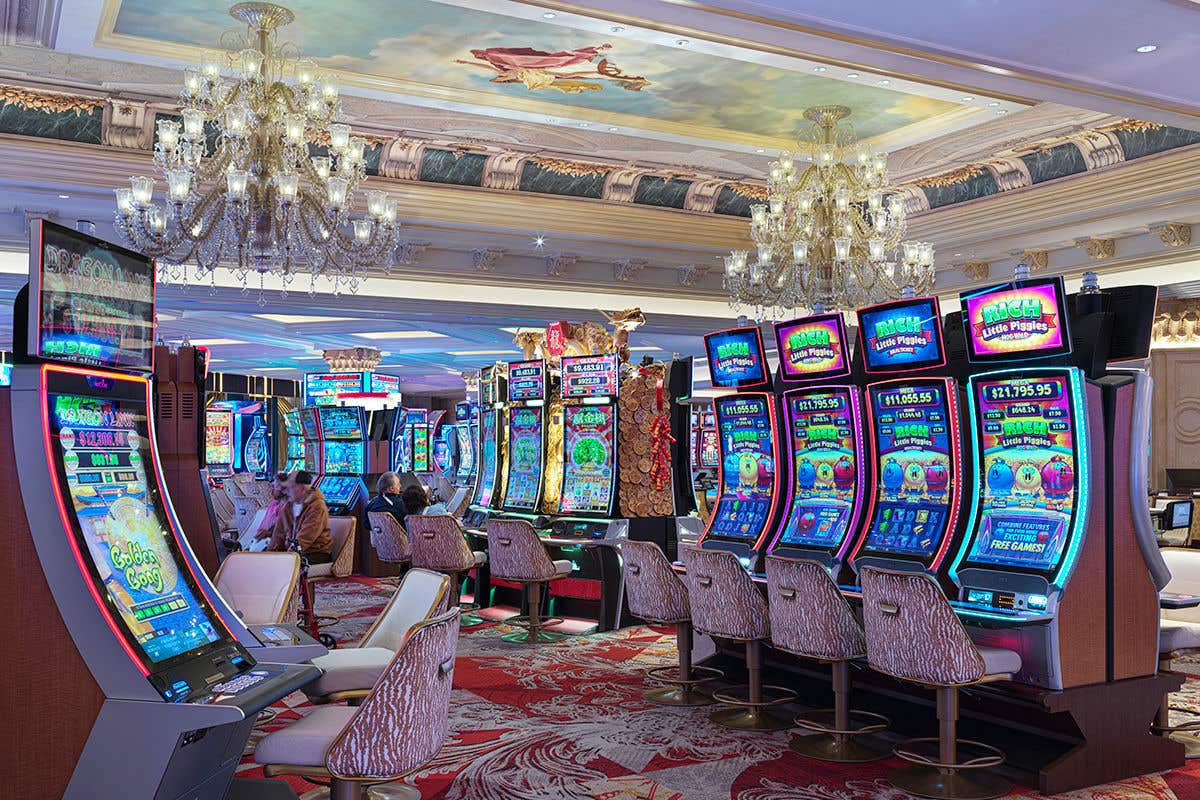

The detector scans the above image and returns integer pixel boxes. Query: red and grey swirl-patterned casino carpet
[239,578,1200,800]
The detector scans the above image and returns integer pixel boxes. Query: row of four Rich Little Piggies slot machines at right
[697,277,1166,688]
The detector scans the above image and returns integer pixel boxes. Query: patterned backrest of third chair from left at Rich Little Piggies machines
[767,555,866,661]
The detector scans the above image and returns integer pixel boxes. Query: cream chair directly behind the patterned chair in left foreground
[304,570,450,705]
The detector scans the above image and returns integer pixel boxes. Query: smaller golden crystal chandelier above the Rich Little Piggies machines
[725,106,934,319]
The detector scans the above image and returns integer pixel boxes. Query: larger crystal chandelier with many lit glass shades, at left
[114,2,400,306]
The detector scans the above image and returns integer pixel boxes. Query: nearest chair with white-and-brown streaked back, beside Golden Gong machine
[254,608,458,800]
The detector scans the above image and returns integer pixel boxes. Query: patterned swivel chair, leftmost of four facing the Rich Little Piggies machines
[620,540,722,705]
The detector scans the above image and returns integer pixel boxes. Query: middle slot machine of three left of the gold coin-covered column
[500,360,546,517]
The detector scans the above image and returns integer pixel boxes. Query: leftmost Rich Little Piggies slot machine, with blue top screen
[697,326,780,569]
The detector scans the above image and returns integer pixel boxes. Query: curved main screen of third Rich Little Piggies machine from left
[863,380,959,559]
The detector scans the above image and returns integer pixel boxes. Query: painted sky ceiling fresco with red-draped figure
[101,0,958,138]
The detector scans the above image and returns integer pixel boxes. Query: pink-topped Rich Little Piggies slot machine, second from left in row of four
[767,313,875,581]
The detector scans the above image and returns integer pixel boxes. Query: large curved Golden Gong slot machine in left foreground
[0,219,320,800]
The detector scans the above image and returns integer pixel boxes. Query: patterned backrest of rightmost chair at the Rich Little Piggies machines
[858,566,985,686]
